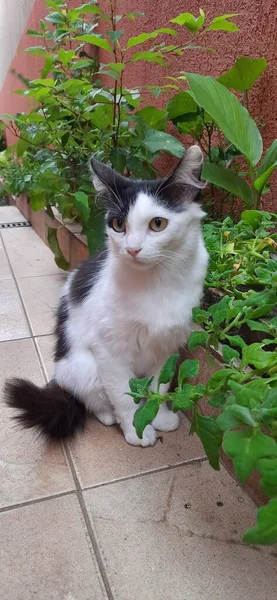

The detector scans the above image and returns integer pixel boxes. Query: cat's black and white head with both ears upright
[91,146,205,268]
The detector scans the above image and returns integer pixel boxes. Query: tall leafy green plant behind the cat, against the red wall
[0,0,239,266]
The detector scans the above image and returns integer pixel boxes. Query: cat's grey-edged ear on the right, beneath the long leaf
[170,145,205,189]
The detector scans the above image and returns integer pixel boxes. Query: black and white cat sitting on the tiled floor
[5,146,208,446]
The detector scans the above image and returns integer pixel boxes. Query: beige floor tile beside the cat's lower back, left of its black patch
[18,273,66,335]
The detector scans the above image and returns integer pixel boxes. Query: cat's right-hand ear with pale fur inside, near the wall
[164,145,206,201]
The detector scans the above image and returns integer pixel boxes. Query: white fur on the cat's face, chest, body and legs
[55,193,208,446]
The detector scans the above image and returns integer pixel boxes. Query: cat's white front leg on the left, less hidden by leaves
[100,357,156,447]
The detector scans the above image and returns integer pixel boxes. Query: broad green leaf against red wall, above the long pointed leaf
[218,56,267,92]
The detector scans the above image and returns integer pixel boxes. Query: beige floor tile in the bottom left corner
[0,496,107,600]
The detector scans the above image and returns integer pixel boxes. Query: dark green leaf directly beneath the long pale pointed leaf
[201,161,252,206]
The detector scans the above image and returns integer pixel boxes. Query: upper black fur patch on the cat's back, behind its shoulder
[69,251,107,305]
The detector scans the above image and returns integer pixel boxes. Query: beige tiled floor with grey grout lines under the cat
[0,208,277,600]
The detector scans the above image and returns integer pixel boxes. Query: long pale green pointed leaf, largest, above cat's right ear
[186,73,263,166]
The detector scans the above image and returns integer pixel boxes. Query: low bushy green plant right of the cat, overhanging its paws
[129,210,277,544]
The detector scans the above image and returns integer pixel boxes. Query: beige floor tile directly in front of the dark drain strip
[2,227,61,278]
